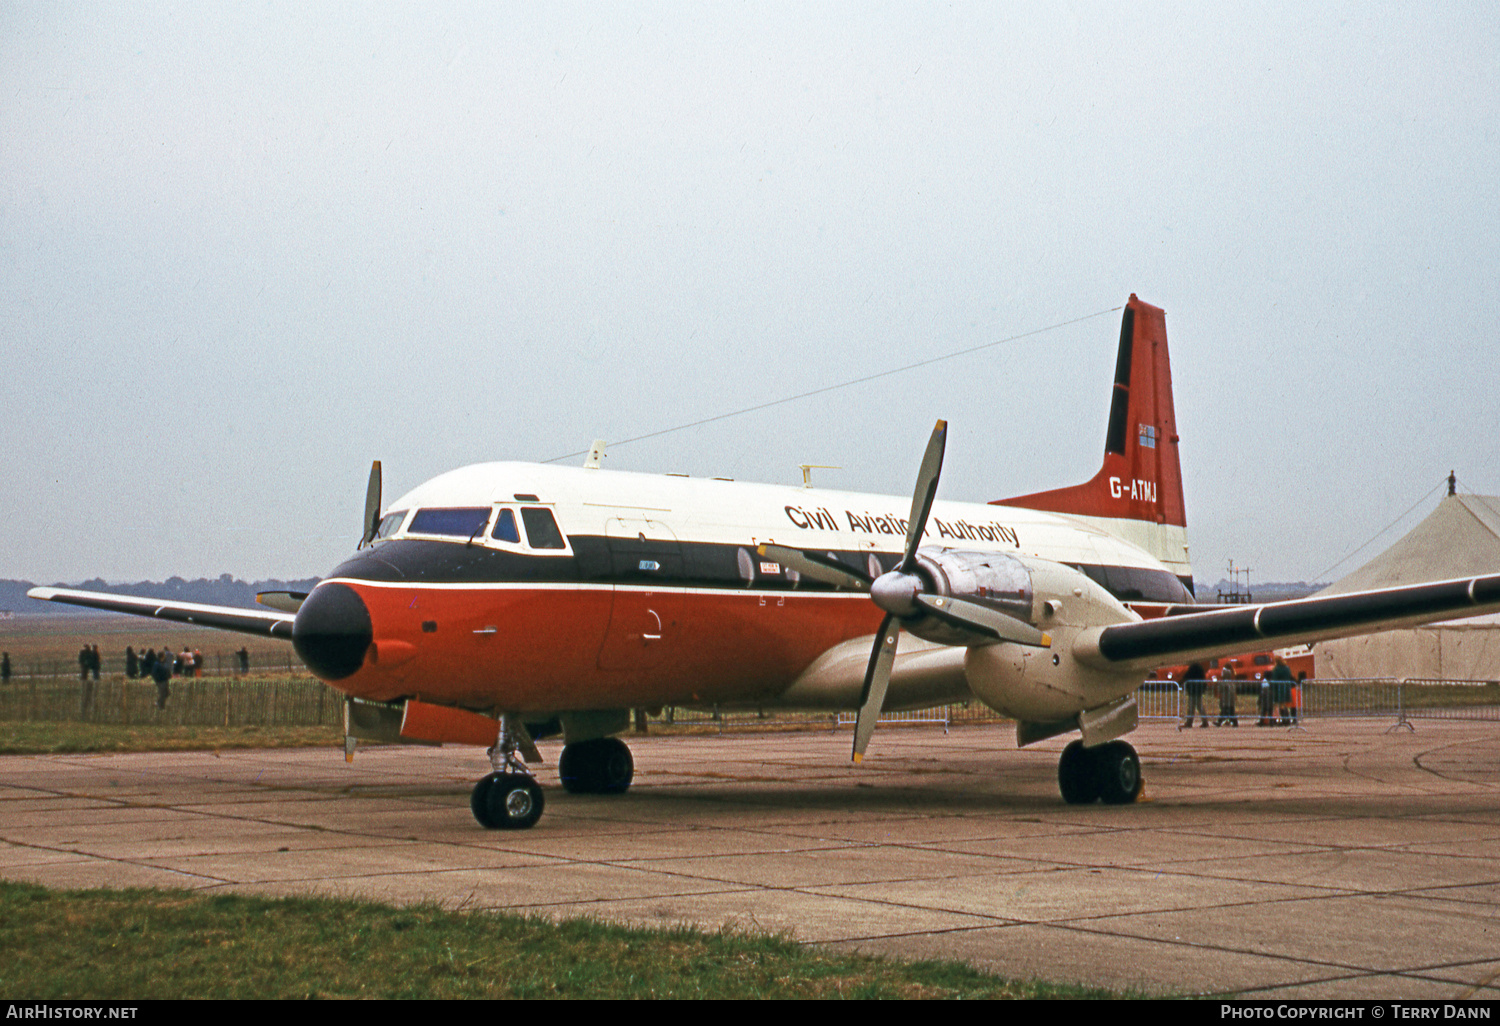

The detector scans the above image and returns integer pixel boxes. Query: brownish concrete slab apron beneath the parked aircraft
[0,720,1500,999]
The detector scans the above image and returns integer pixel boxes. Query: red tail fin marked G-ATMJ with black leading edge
[995,293,1188,528]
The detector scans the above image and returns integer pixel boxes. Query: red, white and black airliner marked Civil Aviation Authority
[30,296,1500,828]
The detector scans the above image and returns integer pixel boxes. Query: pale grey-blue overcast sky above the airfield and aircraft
[0,2,1500,582]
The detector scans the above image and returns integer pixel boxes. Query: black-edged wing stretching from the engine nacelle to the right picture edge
[1074,575,1500,669]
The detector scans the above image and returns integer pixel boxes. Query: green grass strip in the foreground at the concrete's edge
[0,882,1122,1001]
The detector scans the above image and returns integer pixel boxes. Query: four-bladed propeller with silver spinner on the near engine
[758,420,1052,764]
